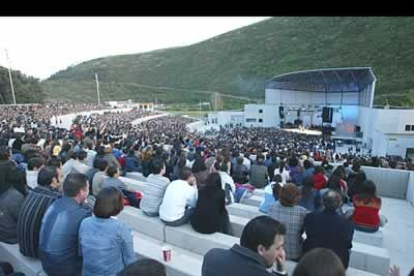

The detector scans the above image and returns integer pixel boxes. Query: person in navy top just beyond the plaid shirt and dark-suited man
[298,176,322,212]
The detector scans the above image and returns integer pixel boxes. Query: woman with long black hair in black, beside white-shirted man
[190,172,231,234]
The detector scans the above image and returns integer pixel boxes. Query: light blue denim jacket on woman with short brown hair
[79,216,136,276]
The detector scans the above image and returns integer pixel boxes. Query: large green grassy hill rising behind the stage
[42,17,414,108]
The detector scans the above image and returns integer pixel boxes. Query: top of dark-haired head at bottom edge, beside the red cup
[117,259,168,276]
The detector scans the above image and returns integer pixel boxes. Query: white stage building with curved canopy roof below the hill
[209,67,414,157]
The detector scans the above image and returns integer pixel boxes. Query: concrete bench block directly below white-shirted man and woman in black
[165,224,239,255]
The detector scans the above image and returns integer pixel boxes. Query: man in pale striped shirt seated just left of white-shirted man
[140,158,170,217]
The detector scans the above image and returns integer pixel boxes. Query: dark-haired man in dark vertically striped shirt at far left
[17,166,62,258]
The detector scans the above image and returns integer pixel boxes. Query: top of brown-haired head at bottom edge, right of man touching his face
[293,248,346,276]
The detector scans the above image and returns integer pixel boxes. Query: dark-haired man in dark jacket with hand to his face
[202,216,287,276]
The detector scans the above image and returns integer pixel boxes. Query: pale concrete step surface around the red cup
[133,232,203,276]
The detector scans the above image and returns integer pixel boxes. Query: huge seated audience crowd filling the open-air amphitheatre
[0,104,414,276]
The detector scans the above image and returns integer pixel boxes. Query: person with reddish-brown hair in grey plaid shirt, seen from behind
[269,183,308,261]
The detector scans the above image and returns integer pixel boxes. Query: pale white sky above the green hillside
[0,17,269,80]
